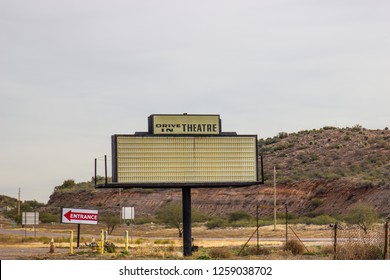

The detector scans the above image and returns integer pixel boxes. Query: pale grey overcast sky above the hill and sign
[0,0,390,202]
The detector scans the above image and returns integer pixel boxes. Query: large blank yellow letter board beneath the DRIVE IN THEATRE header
[116,135,258,184]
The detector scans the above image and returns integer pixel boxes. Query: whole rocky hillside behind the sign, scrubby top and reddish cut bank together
[44,126,390,216]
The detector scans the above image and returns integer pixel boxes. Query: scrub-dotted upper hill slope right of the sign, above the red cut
[258,125,390,184]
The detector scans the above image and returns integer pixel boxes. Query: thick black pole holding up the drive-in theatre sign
[182,188,192,257]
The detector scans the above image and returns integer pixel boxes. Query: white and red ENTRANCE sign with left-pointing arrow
[61,208,99,225]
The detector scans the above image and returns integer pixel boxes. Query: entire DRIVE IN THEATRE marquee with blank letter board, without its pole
[105,115,261,188]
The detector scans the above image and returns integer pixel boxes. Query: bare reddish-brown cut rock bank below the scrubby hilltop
[49,179,390,216]
